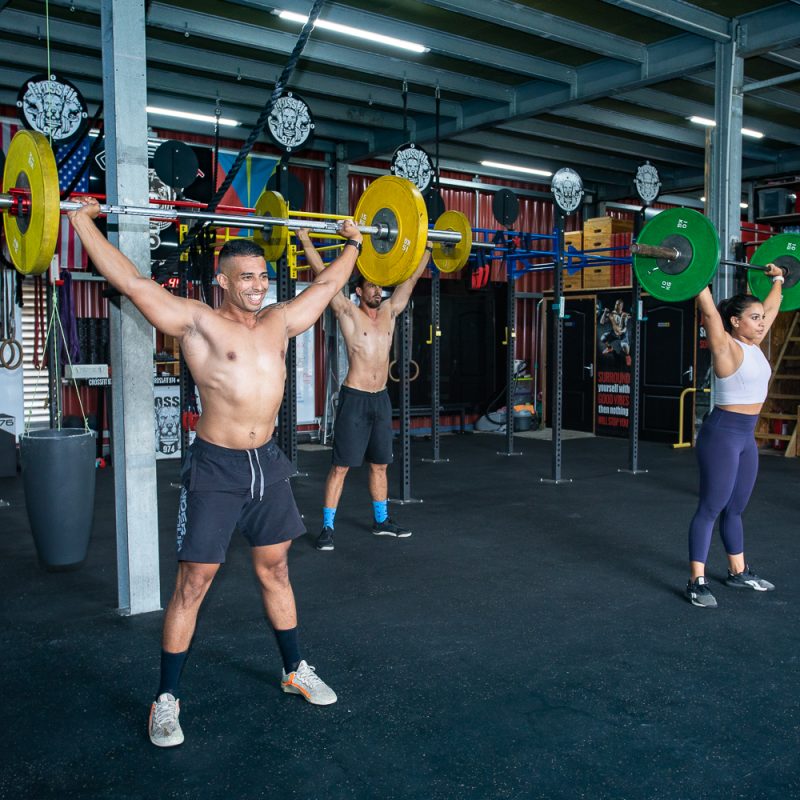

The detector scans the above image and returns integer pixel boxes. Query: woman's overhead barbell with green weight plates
[631,208,800,311]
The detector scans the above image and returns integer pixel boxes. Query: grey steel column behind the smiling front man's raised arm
[101,0,161,614]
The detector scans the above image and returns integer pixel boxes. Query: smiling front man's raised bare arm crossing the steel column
[67,197,203,336]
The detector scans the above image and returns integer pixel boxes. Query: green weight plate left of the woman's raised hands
[633,208,719,303]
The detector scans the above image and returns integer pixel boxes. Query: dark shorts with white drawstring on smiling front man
[178,438,306,564]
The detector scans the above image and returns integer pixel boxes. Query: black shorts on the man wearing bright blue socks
[333,386,392,467]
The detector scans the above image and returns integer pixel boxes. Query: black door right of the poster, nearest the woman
[641,297,695,443]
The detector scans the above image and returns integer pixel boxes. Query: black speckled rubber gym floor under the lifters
[0,434,800,800]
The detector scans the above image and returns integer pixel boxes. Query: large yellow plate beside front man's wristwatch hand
[353,175,428,286]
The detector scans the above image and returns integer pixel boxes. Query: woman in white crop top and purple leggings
[686,264,784,608]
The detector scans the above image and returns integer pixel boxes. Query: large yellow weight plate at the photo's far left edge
[3,130,61,275]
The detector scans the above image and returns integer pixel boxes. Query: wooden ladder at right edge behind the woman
[755,311,800,458]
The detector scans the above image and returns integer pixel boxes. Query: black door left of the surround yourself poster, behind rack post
[547,299,595,431]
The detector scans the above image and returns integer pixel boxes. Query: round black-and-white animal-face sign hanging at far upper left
[17,75,89,144]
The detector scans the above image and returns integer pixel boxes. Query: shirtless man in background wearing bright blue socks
[297,230,431,550]
